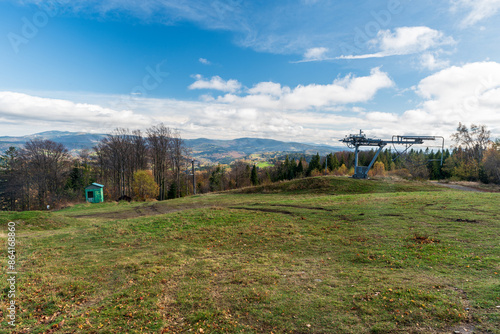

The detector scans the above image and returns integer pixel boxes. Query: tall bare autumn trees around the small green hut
[0,124,188,211]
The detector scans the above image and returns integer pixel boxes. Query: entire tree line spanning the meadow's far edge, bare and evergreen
[0,123,500,210]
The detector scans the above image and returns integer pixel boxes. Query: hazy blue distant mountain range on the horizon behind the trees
[0,131,345,163]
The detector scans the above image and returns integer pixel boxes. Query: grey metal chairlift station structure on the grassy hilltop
[340,130,444,179]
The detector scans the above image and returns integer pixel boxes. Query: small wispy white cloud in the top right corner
[451,0,500,27]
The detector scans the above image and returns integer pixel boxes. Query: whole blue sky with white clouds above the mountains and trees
[0,0,500,144]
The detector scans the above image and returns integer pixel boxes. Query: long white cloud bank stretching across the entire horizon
[0,62,500,145]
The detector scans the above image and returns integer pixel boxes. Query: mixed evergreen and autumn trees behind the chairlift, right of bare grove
[198,123,500,192]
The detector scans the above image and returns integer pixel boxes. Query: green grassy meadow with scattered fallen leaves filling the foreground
[0,177,500,333]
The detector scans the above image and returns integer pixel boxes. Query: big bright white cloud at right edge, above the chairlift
[328,62,500,140]
